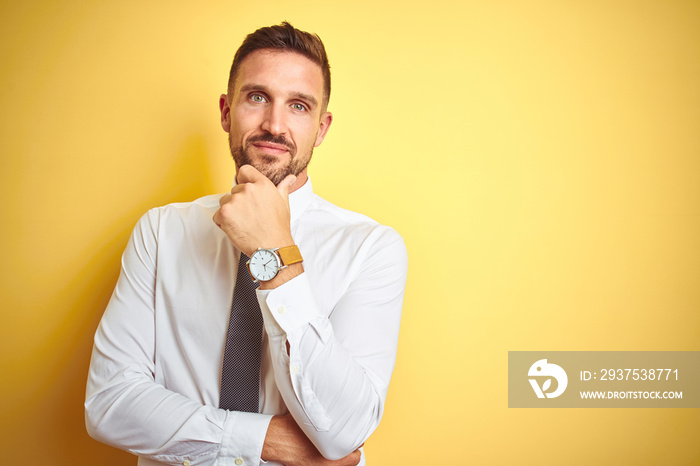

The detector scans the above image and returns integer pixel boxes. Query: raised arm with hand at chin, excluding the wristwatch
[214,165,407,459]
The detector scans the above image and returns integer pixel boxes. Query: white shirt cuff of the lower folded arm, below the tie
[217,411,272,466]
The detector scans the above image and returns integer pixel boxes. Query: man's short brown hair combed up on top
[228,21,331,108]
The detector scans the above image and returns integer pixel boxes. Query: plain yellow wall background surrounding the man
[0,0,700,465]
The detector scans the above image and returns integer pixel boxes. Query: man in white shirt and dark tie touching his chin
[85,23,407,465]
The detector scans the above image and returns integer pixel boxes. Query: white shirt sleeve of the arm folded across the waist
[85,211,271,466]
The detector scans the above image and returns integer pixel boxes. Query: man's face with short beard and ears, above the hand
[219,49,332,185]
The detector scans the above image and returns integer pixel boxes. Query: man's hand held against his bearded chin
[213,165,296,257]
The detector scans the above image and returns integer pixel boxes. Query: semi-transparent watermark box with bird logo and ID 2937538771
[508,350,700,406]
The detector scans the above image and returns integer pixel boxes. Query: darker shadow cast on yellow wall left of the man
[39,135,213,466]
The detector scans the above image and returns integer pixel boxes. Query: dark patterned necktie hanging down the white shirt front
[219,254,263,413]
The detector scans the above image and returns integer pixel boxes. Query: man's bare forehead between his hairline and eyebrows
[234,49,323,102]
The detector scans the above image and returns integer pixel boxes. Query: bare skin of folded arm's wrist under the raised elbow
[261,414,362,466]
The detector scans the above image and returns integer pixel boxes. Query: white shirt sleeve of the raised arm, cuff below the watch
[257,227,408,459]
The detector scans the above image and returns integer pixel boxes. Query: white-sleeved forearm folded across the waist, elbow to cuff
[85,320,271,464]
